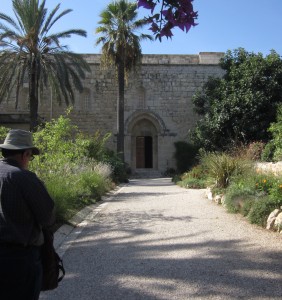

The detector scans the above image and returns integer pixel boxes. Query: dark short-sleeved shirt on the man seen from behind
[0,159,54,246]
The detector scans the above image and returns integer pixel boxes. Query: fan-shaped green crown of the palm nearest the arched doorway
[96,0,152,71]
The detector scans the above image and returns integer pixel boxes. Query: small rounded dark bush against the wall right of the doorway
[174,141,199,173]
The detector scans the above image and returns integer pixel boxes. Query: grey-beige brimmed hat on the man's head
[0,129,39,155]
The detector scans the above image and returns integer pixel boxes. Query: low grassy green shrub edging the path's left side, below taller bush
[35,158,113,223]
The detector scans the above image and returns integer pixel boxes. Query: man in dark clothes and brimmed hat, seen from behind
[0,129,54,300]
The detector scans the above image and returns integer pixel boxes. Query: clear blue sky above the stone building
[0,0,282,55]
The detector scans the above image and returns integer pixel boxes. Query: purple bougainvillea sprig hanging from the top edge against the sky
[137,0,198,41]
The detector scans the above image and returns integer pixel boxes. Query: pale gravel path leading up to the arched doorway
[40,178,282,300]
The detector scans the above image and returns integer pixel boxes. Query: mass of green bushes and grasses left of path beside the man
[26,116,120,222]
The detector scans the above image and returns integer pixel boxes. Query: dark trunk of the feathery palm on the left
[29,56,38,131]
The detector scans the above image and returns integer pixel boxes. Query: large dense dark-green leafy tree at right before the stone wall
[192,48,282,150]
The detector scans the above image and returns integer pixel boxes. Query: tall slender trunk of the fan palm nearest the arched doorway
[117,61,125,162]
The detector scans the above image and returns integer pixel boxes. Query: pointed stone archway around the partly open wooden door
[125,110,166,171]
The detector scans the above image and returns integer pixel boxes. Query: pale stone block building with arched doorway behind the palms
[0,52,223,173]
